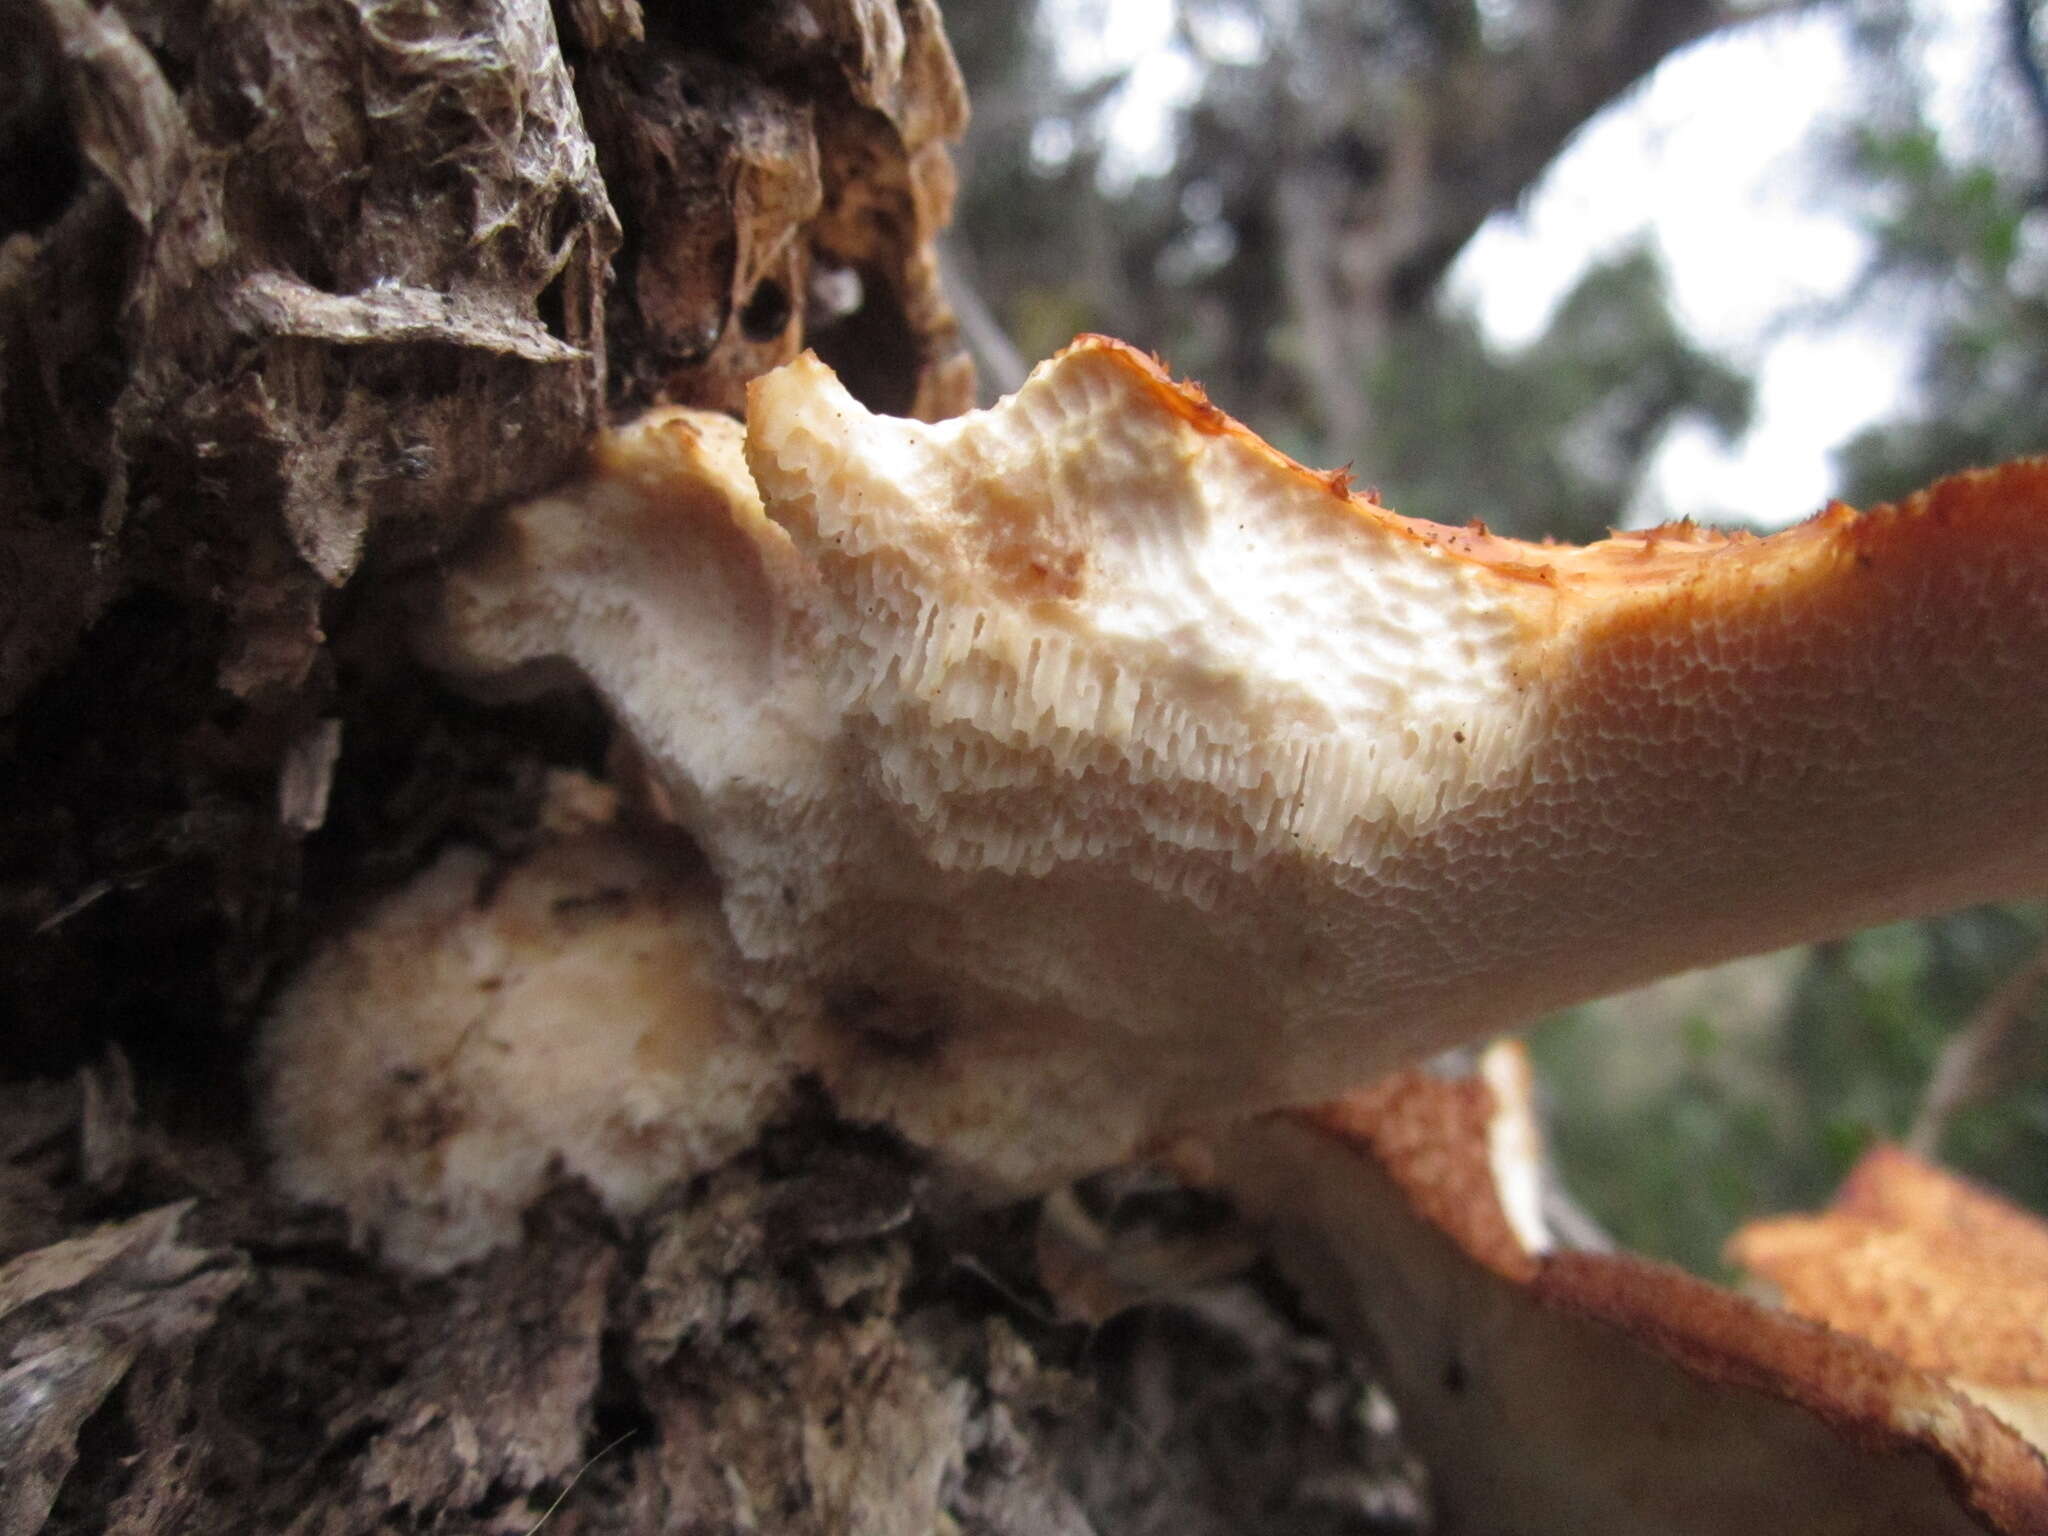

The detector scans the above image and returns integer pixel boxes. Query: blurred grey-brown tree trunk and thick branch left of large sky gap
[946,0,1757,479]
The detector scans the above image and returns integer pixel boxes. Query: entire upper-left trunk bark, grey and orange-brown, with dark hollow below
[0,0,971,1063]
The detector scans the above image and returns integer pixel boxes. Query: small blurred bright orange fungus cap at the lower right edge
[1729,1145,2048,1454]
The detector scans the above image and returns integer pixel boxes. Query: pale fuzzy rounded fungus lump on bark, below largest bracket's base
[258,825,793,1270]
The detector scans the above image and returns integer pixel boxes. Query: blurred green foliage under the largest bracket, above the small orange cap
[1530,903,2048,1274]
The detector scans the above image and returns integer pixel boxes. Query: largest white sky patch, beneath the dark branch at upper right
[1450,16,1875,524]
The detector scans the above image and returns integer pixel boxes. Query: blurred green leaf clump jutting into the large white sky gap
[1368,250,1751,541]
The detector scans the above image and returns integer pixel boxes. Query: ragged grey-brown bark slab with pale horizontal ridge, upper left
[16,0,616,638]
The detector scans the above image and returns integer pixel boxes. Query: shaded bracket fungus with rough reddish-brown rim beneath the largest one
[1212,1047,2048,1536]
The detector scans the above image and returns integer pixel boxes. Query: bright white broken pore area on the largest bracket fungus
[754,350,1526,876]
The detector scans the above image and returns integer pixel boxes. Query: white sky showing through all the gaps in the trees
[1053,0,1999,526]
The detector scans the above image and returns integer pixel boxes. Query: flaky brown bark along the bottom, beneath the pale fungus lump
[0,1056,1423,1536]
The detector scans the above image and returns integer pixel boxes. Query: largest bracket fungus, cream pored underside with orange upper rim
[411,338,2048,1186]
